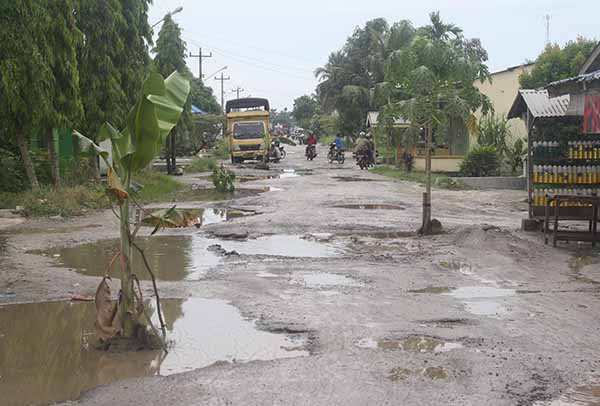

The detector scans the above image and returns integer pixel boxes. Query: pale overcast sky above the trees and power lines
[150,0,600,109]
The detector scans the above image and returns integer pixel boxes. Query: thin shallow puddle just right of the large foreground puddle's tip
[357,336,463,353]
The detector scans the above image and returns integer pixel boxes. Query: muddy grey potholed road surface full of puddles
[0,147,600,406]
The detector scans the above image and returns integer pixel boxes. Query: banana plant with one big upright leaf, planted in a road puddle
[74,72,190,344]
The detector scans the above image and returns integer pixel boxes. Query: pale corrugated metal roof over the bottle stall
[508,90,570,118]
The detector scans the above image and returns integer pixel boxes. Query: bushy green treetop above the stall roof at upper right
[519,37,598,89]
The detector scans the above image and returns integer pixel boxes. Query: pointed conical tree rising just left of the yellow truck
[154,14,192,175]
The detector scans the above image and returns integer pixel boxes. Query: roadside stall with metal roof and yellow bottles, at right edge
[508,42,600,245]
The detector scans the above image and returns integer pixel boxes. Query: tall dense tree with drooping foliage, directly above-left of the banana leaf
[76,0,152,177]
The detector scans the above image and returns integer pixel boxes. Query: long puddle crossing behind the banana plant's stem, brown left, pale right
[31,234,338,281]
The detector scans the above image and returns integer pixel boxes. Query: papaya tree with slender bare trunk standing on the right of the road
[380,13,489,234]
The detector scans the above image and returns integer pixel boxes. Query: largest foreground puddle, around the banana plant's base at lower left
[0,299,309,406]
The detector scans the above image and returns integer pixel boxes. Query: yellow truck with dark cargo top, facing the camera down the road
[225,98,271,164]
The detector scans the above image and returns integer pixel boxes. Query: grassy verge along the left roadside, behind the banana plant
[0,171,185,217]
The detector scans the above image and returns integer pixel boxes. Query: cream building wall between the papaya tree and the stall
[471,64,533,145]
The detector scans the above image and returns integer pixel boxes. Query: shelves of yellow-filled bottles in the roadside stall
[530,135,600,212]
